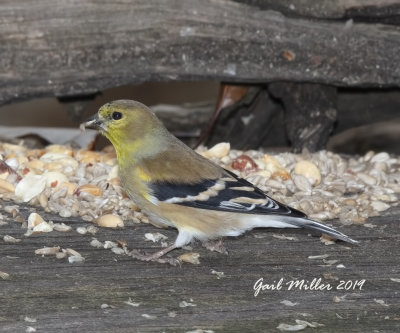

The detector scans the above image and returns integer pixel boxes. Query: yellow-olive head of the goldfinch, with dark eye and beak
[81,100,168,157]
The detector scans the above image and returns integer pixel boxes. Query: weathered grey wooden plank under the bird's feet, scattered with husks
[0,203,400,332]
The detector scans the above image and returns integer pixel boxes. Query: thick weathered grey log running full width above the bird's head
[0,0,400,104]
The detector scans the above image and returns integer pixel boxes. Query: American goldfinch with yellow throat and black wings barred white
[82,100,356,260]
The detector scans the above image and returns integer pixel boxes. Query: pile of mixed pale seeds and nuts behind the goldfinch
[0,143,400,226]
